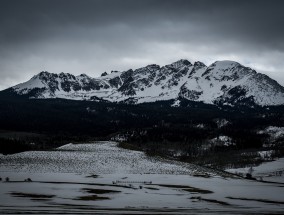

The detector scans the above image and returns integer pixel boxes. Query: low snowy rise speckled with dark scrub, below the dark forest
[0,142,211,175]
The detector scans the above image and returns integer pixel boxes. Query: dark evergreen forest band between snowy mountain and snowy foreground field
[0,96,284,169]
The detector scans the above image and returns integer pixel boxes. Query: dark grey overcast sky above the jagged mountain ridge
[0,0,284,89]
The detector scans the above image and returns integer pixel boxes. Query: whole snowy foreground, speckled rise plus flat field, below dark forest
[0,142,284,214]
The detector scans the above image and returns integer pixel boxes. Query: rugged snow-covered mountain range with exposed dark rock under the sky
[5,60,284,105]
